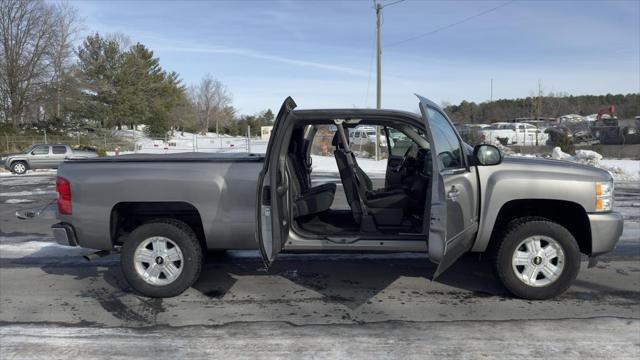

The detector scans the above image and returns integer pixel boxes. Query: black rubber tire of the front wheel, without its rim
[494,218,580,300]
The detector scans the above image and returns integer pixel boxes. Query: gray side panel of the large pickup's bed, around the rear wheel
[58,153,264,250]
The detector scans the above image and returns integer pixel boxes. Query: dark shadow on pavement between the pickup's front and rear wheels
[193,255,509,308]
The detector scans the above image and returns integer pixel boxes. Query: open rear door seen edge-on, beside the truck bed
[256,97,296,267]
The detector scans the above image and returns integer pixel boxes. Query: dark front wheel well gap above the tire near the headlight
[489,199,591,255]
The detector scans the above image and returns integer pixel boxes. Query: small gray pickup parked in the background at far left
[2,144,98,174]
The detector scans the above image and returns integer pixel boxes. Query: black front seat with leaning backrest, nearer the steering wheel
[332,132,409,226]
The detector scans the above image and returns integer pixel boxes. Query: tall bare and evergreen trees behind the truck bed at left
[0,0,273,136]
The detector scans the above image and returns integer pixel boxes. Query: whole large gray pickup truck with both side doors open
[42,96,623,299]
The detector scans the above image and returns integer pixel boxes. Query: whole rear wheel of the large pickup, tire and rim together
[121,219,202,297]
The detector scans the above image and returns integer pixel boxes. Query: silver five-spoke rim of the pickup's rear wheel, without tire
[134,236,184,286]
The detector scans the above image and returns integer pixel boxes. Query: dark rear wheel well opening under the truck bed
[110,201,207,249]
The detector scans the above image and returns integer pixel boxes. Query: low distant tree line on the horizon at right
[442,93,640,124]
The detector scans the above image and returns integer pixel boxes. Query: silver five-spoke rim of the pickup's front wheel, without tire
[511,235,564,287]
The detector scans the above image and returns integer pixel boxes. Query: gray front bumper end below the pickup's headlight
[588,212,624,257]
